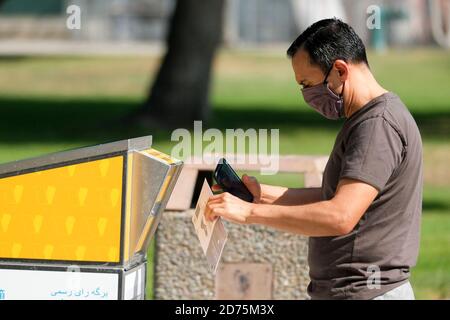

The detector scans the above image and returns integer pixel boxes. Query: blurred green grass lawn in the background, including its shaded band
[0,49,450,299]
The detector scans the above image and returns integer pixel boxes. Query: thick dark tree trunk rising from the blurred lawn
[140,0,224,127]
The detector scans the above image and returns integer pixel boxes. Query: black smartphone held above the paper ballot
[214,158,253,202]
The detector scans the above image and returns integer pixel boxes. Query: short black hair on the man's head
[287,18,369,73]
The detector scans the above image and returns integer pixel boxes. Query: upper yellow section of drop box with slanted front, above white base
[0,136,183,267]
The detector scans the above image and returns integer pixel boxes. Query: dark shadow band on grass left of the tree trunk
[0,99,148,143]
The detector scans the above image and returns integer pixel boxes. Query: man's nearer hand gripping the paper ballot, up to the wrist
[205,192,256,224]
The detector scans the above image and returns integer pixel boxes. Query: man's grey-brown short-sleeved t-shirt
[308,92,422,299]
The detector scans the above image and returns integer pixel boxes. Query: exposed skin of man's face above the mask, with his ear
[291,49,342,92]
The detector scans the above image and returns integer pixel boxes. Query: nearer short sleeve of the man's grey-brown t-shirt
[340,117,403,191]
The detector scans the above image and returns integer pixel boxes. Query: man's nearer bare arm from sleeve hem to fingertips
[205,179,378,237]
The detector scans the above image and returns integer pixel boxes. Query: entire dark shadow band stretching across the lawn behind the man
[0,98,450,143]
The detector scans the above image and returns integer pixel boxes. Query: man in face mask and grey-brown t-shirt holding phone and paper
[206,19,422,299]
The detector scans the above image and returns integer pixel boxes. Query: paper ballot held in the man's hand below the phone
[192,179,227,273]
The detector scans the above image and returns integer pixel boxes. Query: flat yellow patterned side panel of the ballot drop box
[0,156,124,262]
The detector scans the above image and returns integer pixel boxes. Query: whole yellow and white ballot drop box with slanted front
[0,136,183,299]
